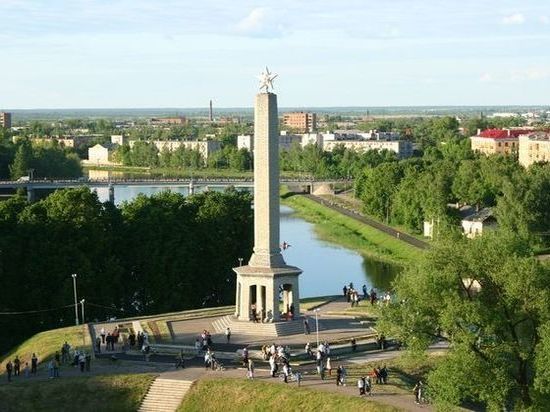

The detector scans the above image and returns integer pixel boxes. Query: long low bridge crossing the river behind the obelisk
[0,177,353,202]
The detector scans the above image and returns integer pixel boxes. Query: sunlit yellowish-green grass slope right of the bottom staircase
[178,379,397,412]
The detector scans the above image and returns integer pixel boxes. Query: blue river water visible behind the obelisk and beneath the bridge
[92,185,399,297]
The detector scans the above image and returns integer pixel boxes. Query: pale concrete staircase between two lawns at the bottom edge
[138,378,193,412]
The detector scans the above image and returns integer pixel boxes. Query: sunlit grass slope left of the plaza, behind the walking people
[0,325,91,372]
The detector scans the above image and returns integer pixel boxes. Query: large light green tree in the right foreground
[379,231,550,410]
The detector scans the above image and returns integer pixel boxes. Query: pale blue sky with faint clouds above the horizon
[0,0,550,109]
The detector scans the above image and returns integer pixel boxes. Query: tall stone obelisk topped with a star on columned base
[233,67,302,322]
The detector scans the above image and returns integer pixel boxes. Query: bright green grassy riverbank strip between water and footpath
[281,189,424,266]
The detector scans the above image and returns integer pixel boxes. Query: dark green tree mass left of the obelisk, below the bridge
[0,188,253,348]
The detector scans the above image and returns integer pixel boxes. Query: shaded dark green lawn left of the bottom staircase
[0,374,155,412]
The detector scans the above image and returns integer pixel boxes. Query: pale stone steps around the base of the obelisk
[212,315,314,337]
